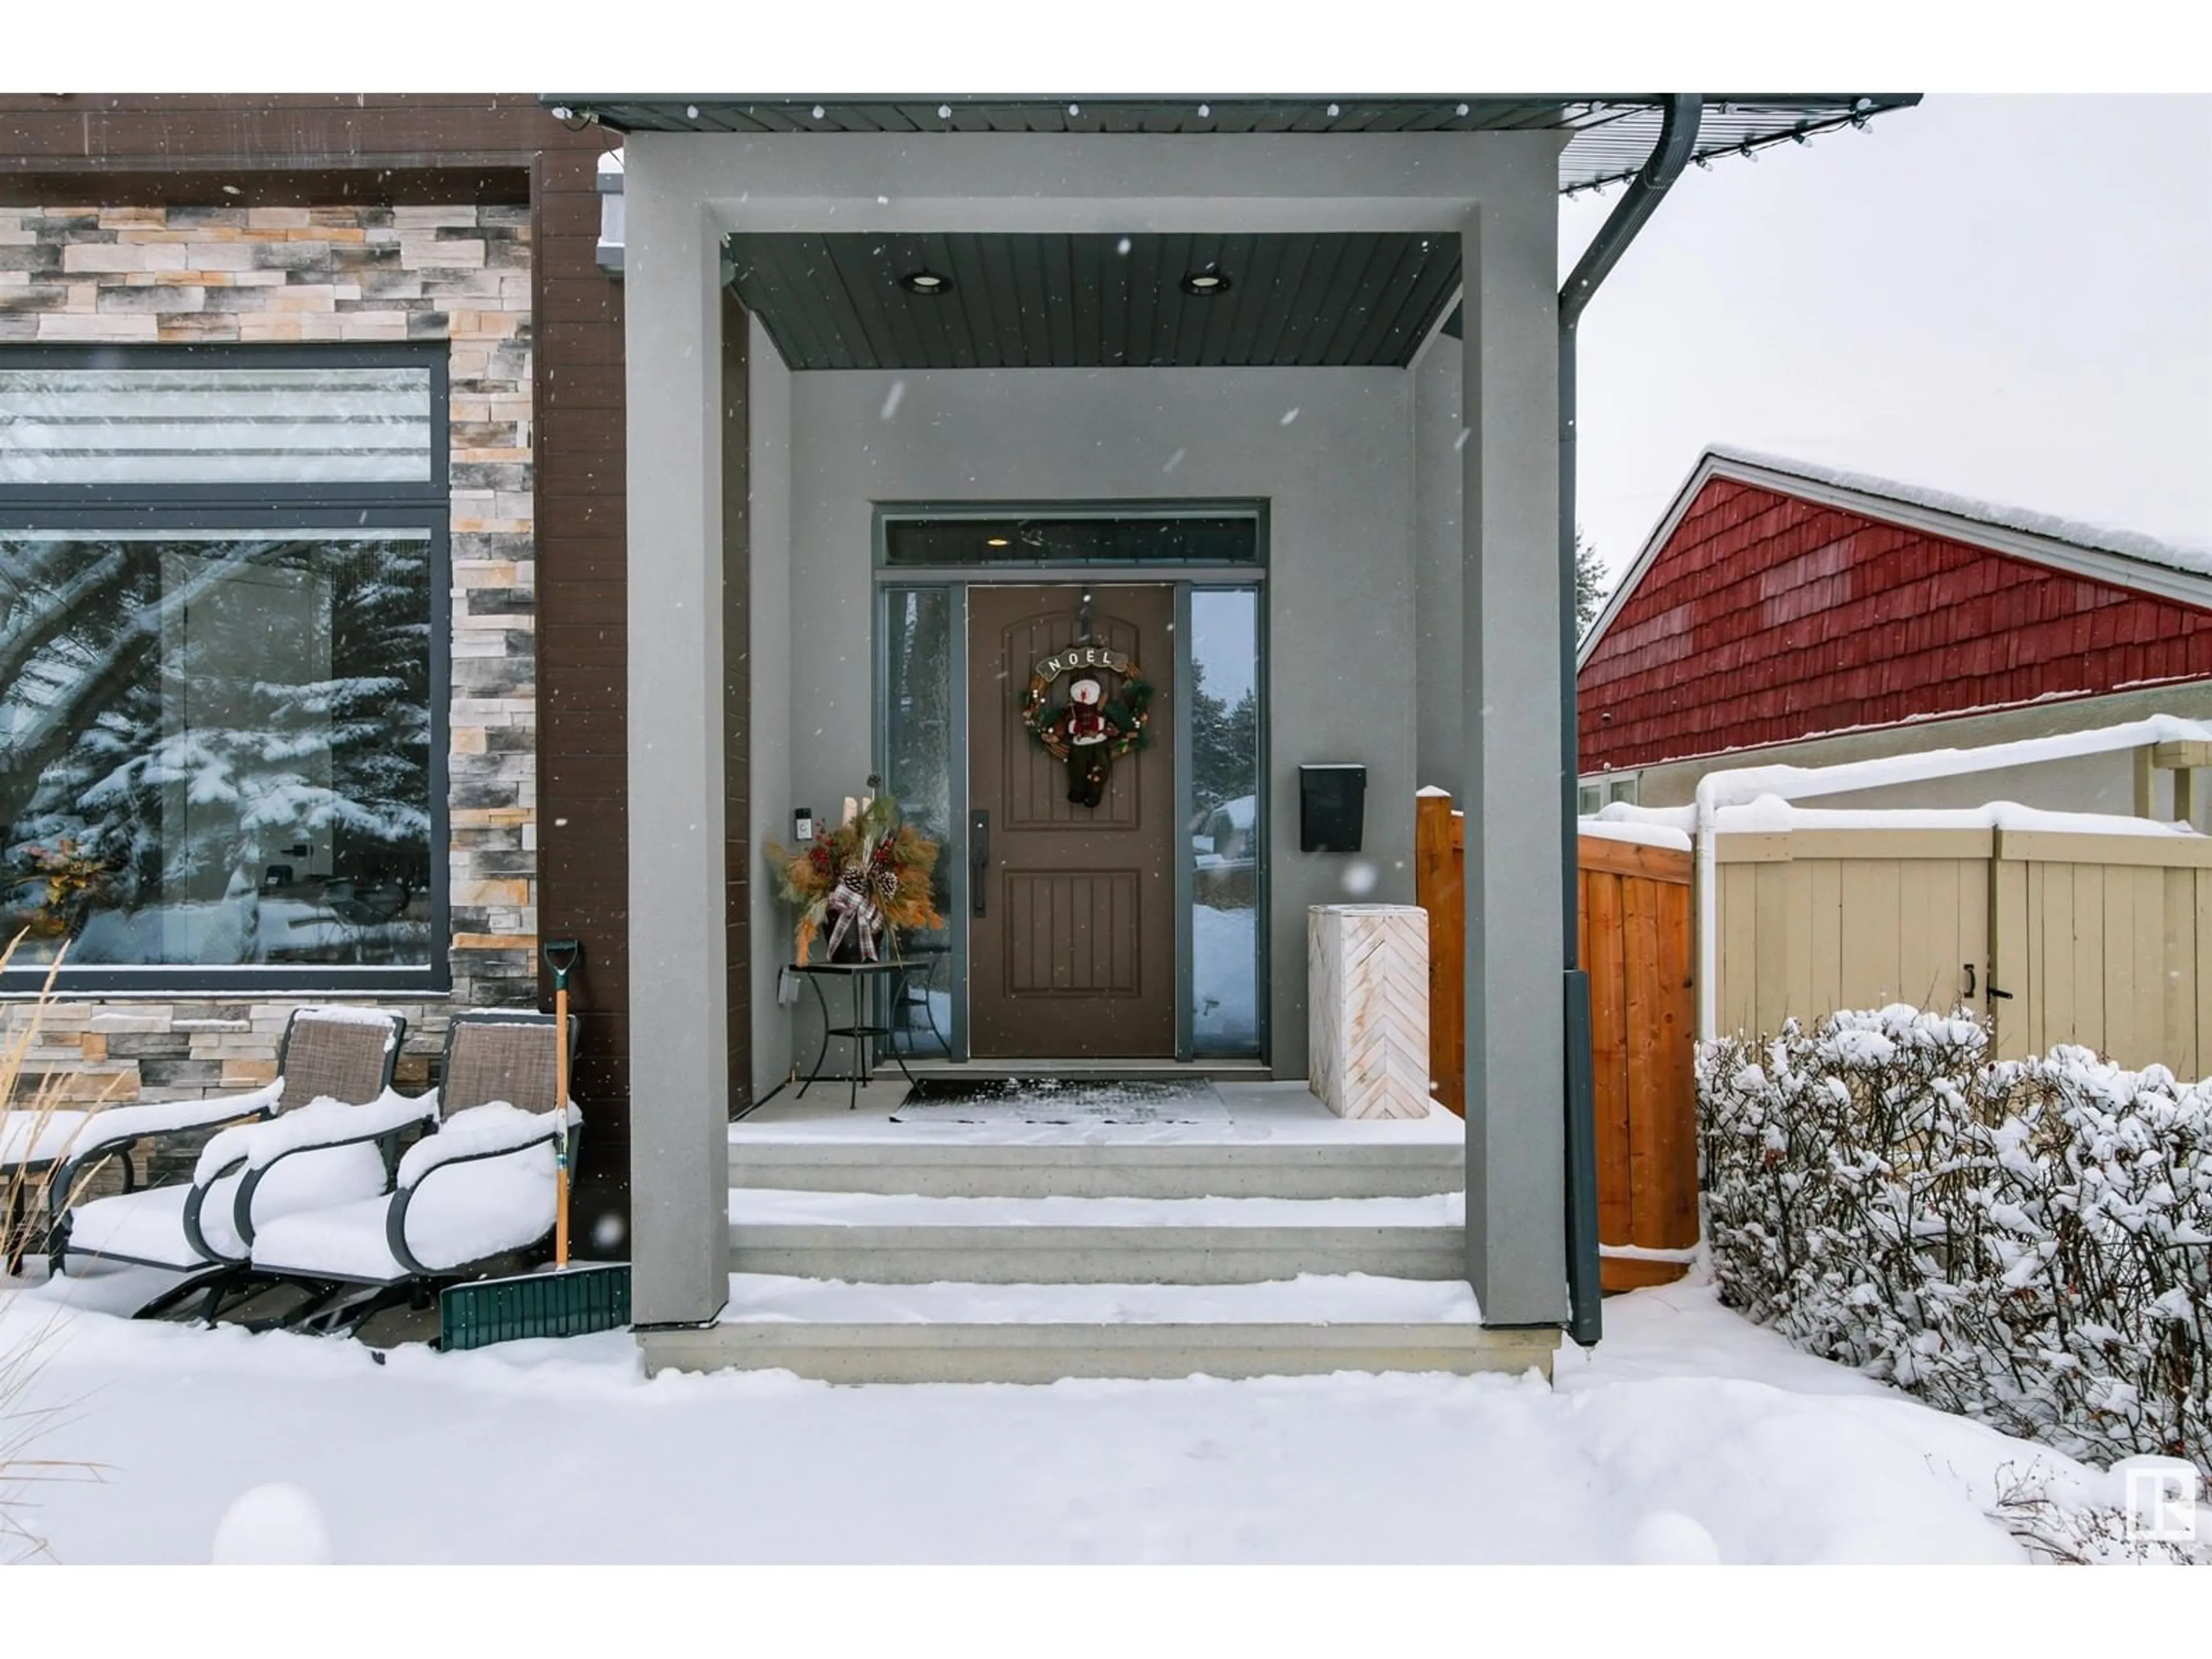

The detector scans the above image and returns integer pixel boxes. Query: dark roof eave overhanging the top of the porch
[540,93,1920,195]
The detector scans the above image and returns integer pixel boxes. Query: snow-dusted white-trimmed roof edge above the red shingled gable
[1575,445,2212,666]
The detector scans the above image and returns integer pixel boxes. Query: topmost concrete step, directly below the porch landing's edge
[730,1126,1467,1199]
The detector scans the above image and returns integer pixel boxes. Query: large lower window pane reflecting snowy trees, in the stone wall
[0,531,431,964]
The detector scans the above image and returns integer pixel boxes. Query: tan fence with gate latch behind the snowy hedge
[1714,827,2212,1077]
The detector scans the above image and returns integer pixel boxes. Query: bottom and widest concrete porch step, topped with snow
[639,1274,1559,1382]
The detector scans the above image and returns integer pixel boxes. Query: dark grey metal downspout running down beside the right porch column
[1559,93,1706,1347]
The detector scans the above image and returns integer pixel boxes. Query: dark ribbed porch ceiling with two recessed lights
[728,232,1460,369]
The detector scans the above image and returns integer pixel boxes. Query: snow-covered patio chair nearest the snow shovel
[239,1011,582,1332]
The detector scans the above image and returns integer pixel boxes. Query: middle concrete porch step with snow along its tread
[730,1190,1467,1285]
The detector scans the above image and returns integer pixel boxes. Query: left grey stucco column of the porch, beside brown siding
[624,132,730,1325]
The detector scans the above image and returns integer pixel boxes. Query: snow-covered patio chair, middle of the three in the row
[47,1009,425,1314]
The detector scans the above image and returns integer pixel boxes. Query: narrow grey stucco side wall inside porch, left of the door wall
[745,323,805,1099]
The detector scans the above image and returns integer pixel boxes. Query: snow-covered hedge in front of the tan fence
[1696,1004,2212,1471]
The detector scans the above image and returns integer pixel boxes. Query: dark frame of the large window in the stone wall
[0,340,453,998]
